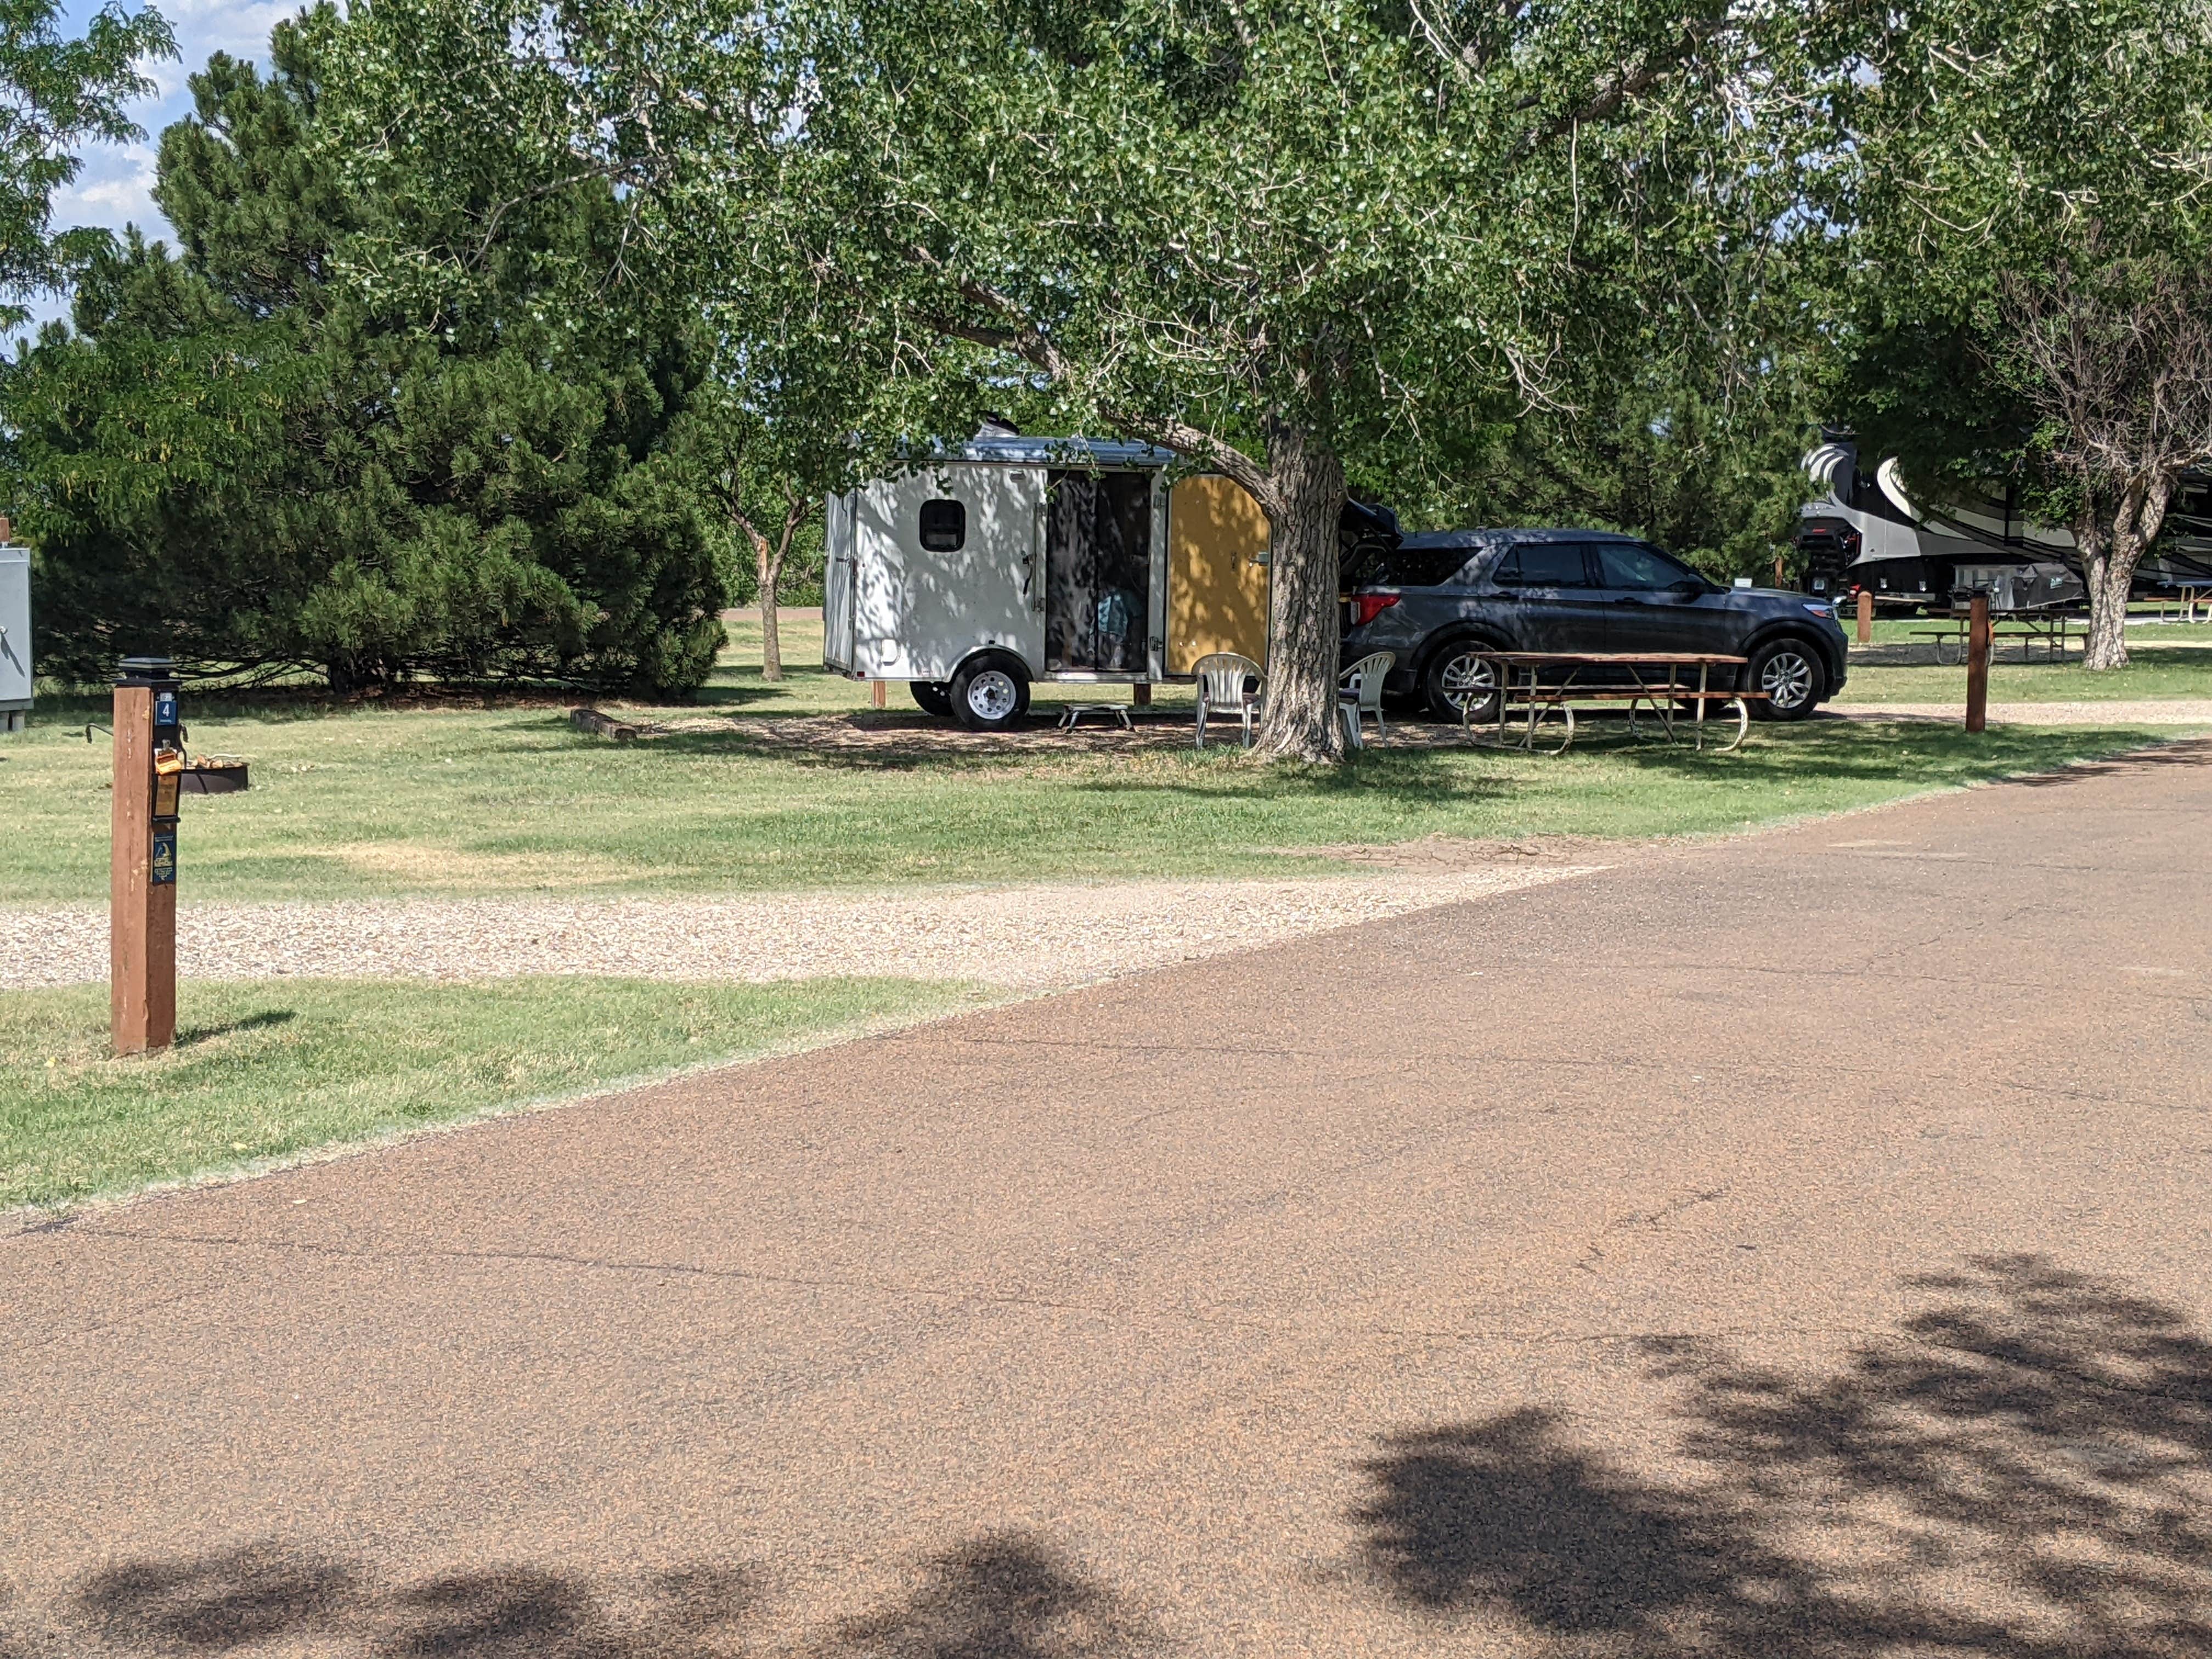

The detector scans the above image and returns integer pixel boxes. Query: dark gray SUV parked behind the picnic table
[1345,531,1845,721]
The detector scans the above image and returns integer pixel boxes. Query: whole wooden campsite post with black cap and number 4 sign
[109,657,184,1055]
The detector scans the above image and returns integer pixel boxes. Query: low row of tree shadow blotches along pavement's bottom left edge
[47,1533,1144,1659]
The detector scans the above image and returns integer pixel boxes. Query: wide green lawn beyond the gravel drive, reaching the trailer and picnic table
[0,624,2212,902]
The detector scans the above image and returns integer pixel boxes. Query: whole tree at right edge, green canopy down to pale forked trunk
[1825,0,2212,668]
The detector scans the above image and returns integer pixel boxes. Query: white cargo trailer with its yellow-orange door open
[823,431,1267,730]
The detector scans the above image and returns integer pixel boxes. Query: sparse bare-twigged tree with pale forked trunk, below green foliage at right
[2002,253,2212,668]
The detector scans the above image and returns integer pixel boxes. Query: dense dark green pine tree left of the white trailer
[0,9,728,692]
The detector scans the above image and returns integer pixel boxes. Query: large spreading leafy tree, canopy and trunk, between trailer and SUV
[323,0,1812,759]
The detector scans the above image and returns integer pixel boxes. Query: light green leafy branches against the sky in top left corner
[0,0,177,328]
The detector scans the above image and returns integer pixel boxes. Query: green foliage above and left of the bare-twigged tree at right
[1827,0,2212,546]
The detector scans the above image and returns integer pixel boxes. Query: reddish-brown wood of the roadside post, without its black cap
[109,686,177,1055]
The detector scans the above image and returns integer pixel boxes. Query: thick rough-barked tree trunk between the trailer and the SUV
[1256,427,1345,761]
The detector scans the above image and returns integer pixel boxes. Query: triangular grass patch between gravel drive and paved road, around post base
[0,978,982,1212]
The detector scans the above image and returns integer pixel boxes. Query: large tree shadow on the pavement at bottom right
[1356,1256,2212,1659]
